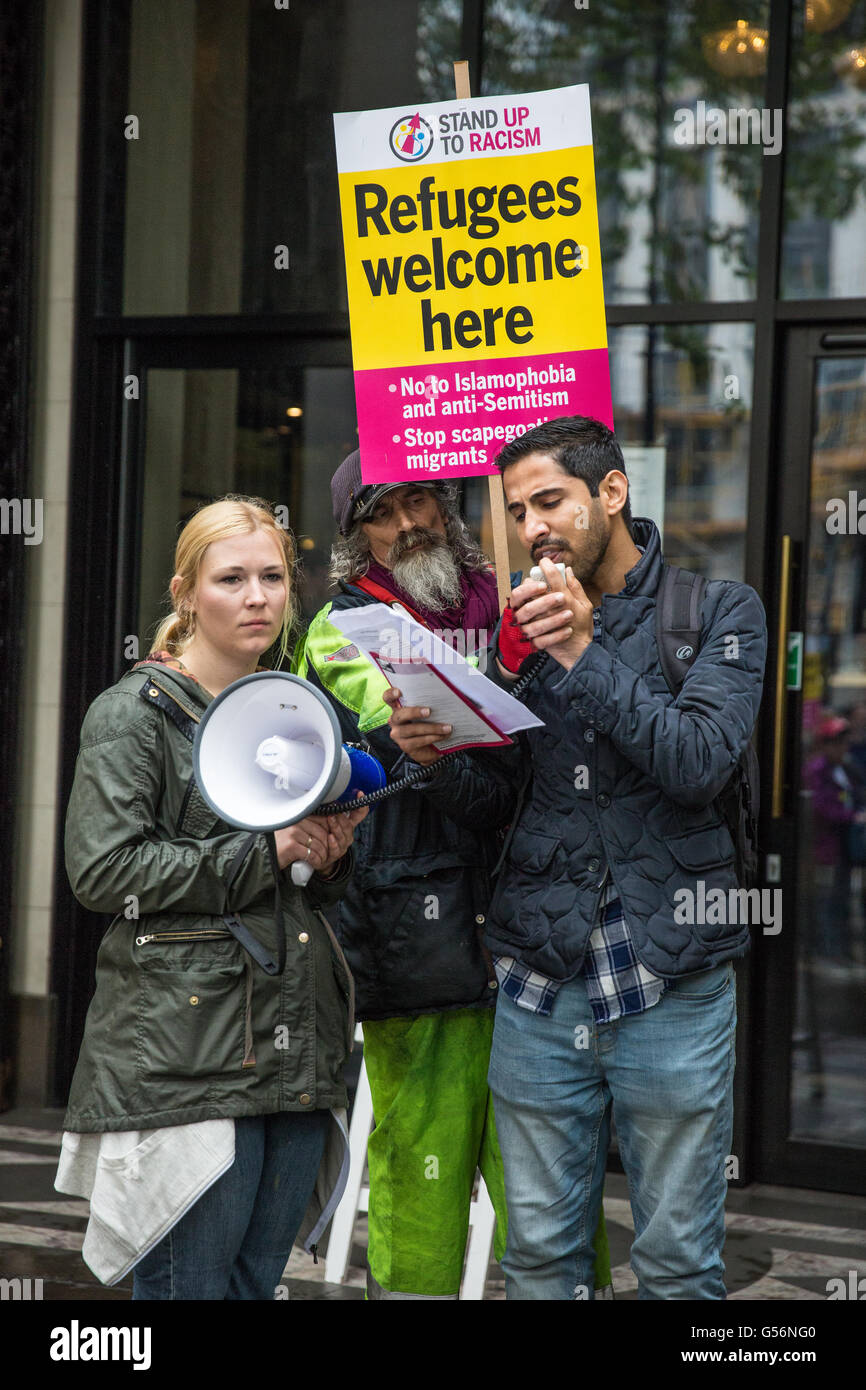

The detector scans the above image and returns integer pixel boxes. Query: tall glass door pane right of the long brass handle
[791,357,866,1145]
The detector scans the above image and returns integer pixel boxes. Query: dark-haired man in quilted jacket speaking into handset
[386,416,766,1300]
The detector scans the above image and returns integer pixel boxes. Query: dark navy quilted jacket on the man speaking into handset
[422,518,767,980]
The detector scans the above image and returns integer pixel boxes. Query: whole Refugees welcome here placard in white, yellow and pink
[334,85,613,482]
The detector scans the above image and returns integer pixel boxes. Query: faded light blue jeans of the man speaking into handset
[489,962,737,1300]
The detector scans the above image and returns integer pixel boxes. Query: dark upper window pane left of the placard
[119,0,463,314]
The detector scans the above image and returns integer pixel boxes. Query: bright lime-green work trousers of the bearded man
[364,1009,610,1298]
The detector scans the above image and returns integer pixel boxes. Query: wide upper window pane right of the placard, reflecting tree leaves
[484,0,781,304]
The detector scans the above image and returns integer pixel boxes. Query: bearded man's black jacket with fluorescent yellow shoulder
[292,585,518,1019]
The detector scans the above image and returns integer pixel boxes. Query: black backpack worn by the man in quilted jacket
[656,564,760,888]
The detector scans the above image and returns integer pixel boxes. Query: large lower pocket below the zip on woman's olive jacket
[136,931,249,1079]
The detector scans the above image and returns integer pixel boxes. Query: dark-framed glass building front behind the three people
[0,0,866,1193]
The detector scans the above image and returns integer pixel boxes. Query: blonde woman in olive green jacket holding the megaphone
[56,496,366,1300]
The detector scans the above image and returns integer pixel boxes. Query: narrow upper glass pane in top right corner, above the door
[781,0,866,299]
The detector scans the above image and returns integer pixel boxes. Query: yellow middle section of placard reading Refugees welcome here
[339,145,607,371]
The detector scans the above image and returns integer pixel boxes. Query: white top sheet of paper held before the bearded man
[328,603,544,734]
